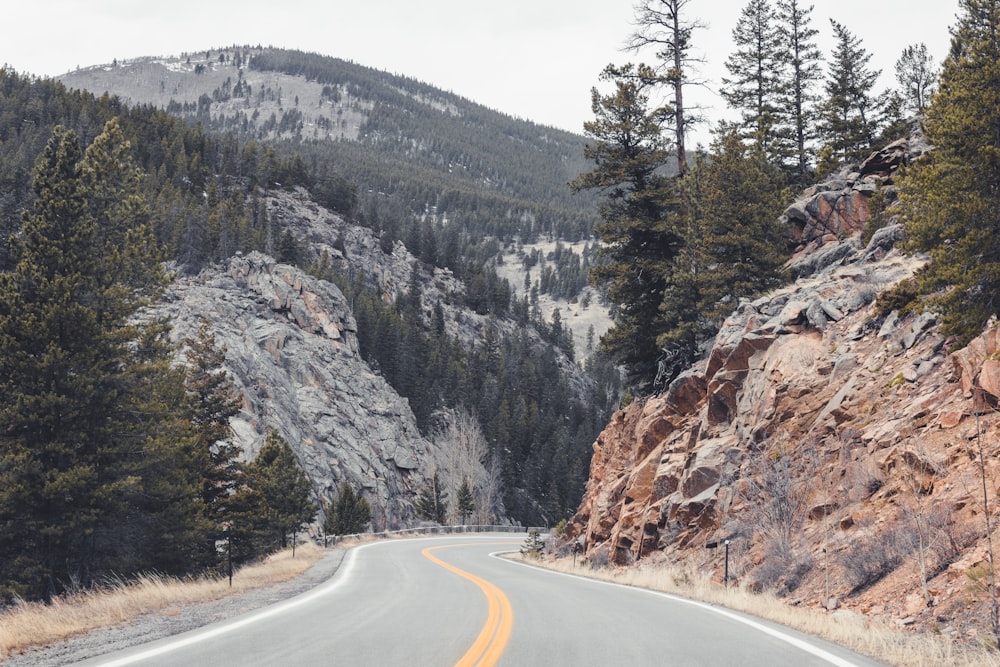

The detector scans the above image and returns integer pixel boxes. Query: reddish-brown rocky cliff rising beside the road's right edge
[567,134,1000,633]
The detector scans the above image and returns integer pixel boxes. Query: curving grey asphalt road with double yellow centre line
[80,534,878,667]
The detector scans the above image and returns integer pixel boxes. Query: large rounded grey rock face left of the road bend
[154,253,443,528]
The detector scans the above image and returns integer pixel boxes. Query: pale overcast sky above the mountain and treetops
[0,0,958,142]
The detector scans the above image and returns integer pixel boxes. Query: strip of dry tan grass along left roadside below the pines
[0,543,323,660]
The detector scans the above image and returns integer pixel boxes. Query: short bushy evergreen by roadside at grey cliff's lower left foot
[247,431,319,548]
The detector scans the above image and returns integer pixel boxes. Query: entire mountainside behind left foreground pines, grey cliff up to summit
[0,49,617,526]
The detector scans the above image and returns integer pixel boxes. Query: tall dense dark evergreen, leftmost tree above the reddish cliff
[571,65,682,392]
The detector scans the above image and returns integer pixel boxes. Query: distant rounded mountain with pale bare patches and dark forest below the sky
[59,46,611,422]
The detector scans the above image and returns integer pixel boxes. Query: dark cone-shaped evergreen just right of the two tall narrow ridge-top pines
[820,19,888,167]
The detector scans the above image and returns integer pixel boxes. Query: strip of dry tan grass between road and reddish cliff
[511,555,1000,667]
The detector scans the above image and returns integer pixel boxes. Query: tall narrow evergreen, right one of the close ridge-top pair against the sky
[777,0,823,186]
